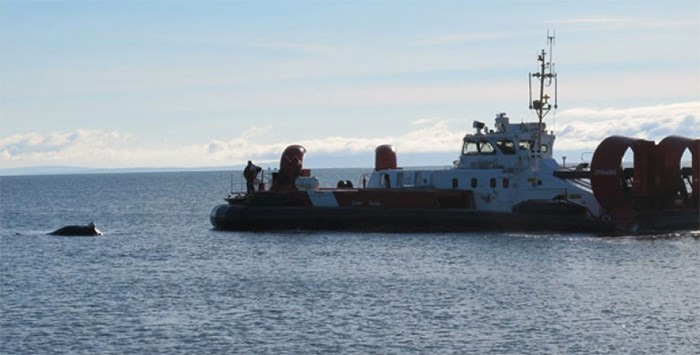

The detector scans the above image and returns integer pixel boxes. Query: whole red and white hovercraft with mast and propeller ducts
[210,37,700,233]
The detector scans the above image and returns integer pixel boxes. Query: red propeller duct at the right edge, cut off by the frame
[658,136,700,209]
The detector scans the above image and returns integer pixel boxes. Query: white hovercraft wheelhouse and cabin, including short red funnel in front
[366,113,598,215]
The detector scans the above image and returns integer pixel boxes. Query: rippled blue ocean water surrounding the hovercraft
[0,169,700,354]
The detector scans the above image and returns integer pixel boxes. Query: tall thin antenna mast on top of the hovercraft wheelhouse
[528,31,558,157]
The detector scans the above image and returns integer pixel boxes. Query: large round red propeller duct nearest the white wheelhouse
[591,136,655,215]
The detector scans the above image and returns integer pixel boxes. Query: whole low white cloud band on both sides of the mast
[0,101,700,168]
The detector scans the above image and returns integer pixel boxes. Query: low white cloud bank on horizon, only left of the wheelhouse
[0,120,463,168]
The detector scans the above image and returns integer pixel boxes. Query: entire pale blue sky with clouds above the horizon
[0,0,700,170]
